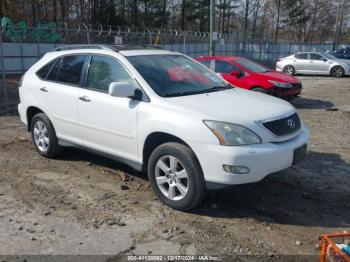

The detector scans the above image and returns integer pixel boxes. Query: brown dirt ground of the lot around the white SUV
[0,77,350,260]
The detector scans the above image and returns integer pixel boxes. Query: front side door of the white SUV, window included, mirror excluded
[78,55,140,161]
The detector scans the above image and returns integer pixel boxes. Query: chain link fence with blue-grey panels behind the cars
[0,24,344,113]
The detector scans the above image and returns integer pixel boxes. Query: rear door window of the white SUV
[58,55,87,85]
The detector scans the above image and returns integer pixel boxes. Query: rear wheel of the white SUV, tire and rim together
[30,113,62,158]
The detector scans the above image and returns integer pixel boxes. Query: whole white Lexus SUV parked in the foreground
[18,46,309,210]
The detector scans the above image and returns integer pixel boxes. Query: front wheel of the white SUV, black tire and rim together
[148,142,206,211]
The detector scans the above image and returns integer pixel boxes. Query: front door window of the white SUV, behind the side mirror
[87,55,132,92]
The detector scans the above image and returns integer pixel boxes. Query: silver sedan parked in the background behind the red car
[276,52,350,77]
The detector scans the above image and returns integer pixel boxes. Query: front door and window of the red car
[214,60,245,88]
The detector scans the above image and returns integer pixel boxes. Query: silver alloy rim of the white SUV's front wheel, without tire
[155,155,189,201]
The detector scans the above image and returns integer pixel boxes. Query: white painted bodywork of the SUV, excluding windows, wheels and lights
[18,49,309,184]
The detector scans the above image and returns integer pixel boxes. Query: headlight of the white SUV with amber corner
[204,120,261,146]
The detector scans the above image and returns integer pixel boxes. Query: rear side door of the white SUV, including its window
[40,54,88,144]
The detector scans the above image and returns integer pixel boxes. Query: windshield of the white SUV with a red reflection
[127,55,233,97]
